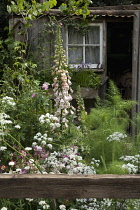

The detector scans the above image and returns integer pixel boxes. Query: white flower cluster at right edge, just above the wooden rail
[120,154,140,174]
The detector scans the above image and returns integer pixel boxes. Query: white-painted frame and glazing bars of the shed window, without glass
[66,23,103,69]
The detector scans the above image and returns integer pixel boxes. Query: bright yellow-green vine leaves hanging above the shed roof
[7,0,90,21]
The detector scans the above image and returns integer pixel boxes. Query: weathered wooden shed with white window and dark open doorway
[10,4,140,113]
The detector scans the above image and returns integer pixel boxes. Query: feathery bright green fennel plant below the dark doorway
[77,81,135,166]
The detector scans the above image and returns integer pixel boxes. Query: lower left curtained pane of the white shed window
[68,47,83,64]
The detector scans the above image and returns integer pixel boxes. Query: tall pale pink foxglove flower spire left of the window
[52,26,75,128]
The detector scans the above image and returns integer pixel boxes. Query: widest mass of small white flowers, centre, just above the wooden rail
[45,147,96,174]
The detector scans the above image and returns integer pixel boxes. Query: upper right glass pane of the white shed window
[85,26,100,44]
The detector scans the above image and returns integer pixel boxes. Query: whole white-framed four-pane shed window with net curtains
[66,23,103,68]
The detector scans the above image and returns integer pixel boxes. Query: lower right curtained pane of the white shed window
[85,47,100,64]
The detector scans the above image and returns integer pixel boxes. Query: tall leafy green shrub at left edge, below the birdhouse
[0,35,51,146]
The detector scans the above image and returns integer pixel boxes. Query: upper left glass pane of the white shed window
[68,27,83,44]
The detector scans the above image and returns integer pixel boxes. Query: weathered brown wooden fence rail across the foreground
[0,174,140,199]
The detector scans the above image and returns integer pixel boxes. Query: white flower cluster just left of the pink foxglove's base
[39,113,61,130]
